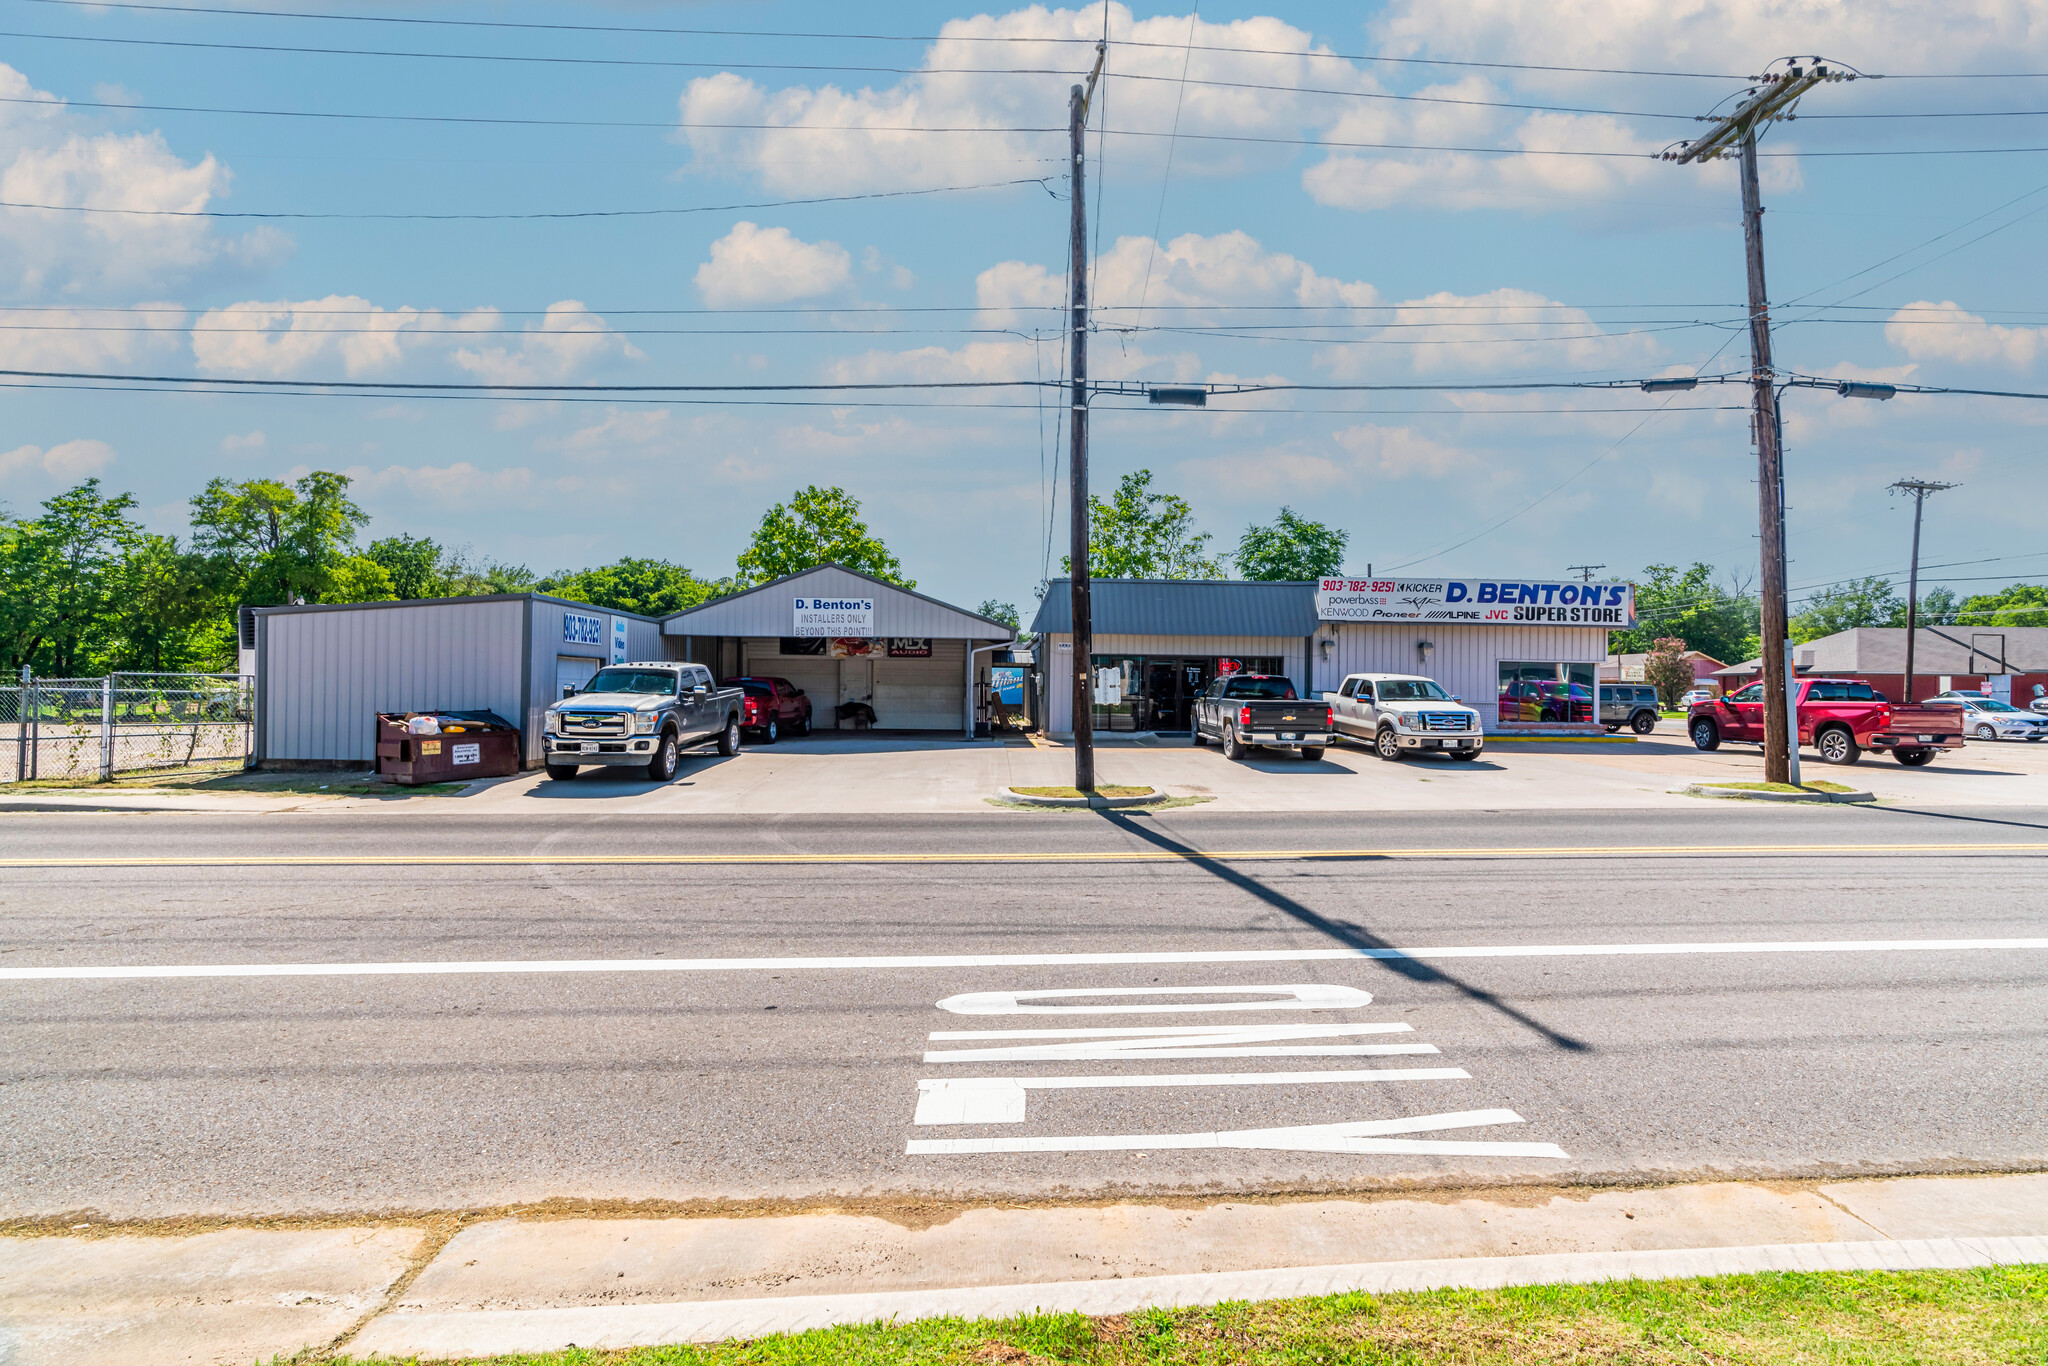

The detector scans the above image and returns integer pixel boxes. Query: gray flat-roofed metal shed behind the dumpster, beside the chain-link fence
[252,594,663,768]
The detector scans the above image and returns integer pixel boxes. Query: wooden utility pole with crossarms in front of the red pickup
[1665,57,1853,782]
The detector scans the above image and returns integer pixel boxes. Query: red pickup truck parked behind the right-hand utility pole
[1686,678,1962,768]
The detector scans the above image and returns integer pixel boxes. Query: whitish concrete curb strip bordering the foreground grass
[348,1237,2048,1360]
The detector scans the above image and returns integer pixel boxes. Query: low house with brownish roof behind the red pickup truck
[1714,627,2048,707]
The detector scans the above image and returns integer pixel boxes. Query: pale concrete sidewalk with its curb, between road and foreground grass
[0,1176,2048,1366]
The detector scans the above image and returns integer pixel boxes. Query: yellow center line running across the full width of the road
[0,842,2048,868]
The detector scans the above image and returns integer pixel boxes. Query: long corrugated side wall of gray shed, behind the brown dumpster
[258,600,528,764]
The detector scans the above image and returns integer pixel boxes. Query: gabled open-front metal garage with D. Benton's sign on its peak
[662,565,1016,737]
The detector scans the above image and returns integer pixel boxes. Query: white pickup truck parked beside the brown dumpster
[543,659,743,782]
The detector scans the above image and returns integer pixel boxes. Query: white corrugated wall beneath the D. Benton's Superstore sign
[1310,623,1608,733]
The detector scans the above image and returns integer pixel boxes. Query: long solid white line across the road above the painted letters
[0,938,2048,981]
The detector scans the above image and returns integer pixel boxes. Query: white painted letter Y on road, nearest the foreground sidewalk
[903,1110,1571,1157]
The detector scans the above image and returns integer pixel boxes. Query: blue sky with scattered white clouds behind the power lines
[0,0,2048,604]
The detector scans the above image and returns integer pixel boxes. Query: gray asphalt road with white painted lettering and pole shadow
[0,803,2048,1216]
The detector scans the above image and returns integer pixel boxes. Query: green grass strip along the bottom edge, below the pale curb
[338,1266,2048,1366]
